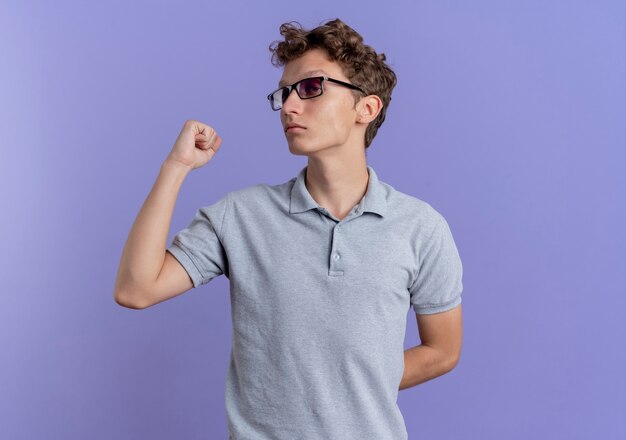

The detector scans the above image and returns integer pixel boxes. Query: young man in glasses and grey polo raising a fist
[115,20,462,440]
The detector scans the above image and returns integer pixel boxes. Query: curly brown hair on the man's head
[269,18,398,149]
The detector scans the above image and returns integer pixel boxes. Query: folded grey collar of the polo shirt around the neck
[289,165,387,217]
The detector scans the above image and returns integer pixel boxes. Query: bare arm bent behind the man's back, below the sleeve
[400,305,463,390]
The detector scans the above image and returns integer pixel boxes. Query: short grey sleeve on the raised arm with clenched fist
[166,194,229,287]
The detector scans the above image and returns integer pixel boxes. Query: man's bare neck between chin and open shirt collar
[305,150,369,220]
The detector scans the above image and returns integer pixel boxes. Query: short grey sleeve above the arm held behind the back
[409,215,463,314]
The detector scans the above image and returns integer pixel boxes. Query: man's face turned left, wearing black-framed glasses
[279,49,363,155]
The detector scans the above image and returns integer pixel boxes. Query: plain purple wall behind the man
[0,0,626,440]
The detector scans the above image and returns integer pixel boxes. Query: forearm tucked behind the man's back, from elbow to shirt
[400,345,454,390]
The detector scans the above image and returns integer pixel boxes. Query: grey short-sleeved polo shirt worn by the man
[167,166,462,440]
